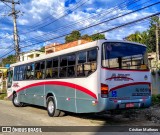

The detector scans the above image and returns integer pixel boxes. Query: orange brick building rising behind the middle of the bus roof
[45,40,90,54]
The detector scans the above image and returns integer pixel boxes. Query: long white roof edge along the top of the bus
[10,39,146,67]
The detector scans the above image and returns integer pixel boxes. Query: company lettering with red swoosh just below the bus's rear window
[106,73,134,81]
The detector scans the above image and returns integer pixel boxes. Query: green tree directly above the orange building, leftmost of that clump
[65,31,81,43]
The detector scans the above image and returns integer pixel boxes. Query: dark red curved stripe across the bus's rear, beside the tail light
[110,82,151,91]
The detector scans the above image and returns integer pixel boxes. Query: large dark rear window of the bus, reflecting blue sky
[102,42,148,70]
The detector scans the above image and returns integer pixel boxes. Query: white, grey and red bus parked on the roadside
[7,40,151,116]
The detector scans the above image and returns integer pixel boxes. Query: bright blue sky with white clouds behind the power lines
[0,0,160,59]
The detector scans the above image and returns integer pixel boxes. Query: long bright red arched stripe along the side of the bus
[13,81,97,99]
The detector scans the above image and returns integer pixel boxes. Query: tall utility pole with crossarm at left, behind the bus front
[0,0,20,62]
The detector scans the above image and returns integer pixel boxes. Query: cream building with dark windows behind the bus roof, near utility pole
[20,50,44,61]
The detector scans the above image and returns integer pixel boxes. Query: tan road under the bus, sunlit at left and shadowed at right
[0,100,160,135]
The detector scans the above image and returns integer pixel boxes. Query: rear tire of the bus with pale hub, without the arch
[47,97,60,117]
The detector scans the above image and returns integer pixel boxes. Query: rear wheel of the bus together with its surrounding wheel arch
[46,93,60,117]
